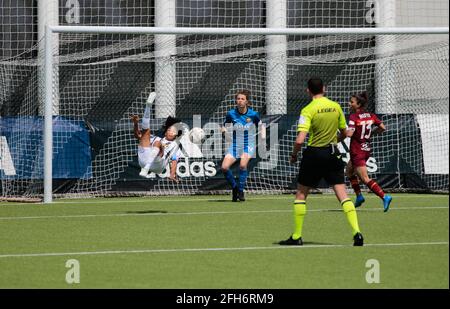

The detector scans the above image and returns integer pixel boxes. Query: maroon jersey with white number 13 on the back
[348,111,381,154]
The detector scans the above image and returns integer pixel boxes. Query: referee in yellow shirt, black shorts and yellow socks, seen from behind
[279,78,364,246]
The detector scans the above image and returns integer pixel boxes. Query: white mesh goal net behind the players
[0,0,449,198]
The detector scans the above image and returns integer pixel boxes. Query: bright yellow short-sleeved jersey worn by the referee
[297,97,347,147]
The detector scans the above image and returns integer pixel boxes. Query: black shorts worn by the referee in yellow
[298,146,345,188]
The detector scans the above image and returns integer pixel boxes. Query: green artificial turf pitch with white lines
[0,194,449,289]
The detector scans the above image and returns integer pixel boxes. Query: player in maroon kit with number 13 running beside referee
[346,92,392,212]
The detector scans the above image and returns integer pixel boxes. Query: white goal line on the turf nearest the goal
[0,206,449,221]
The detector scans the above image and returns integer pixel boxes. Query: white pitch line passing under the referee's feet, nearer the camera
[0,241,449,258]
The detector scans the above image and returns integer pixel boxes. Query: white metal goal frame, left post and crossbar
[38,26,449,203]
